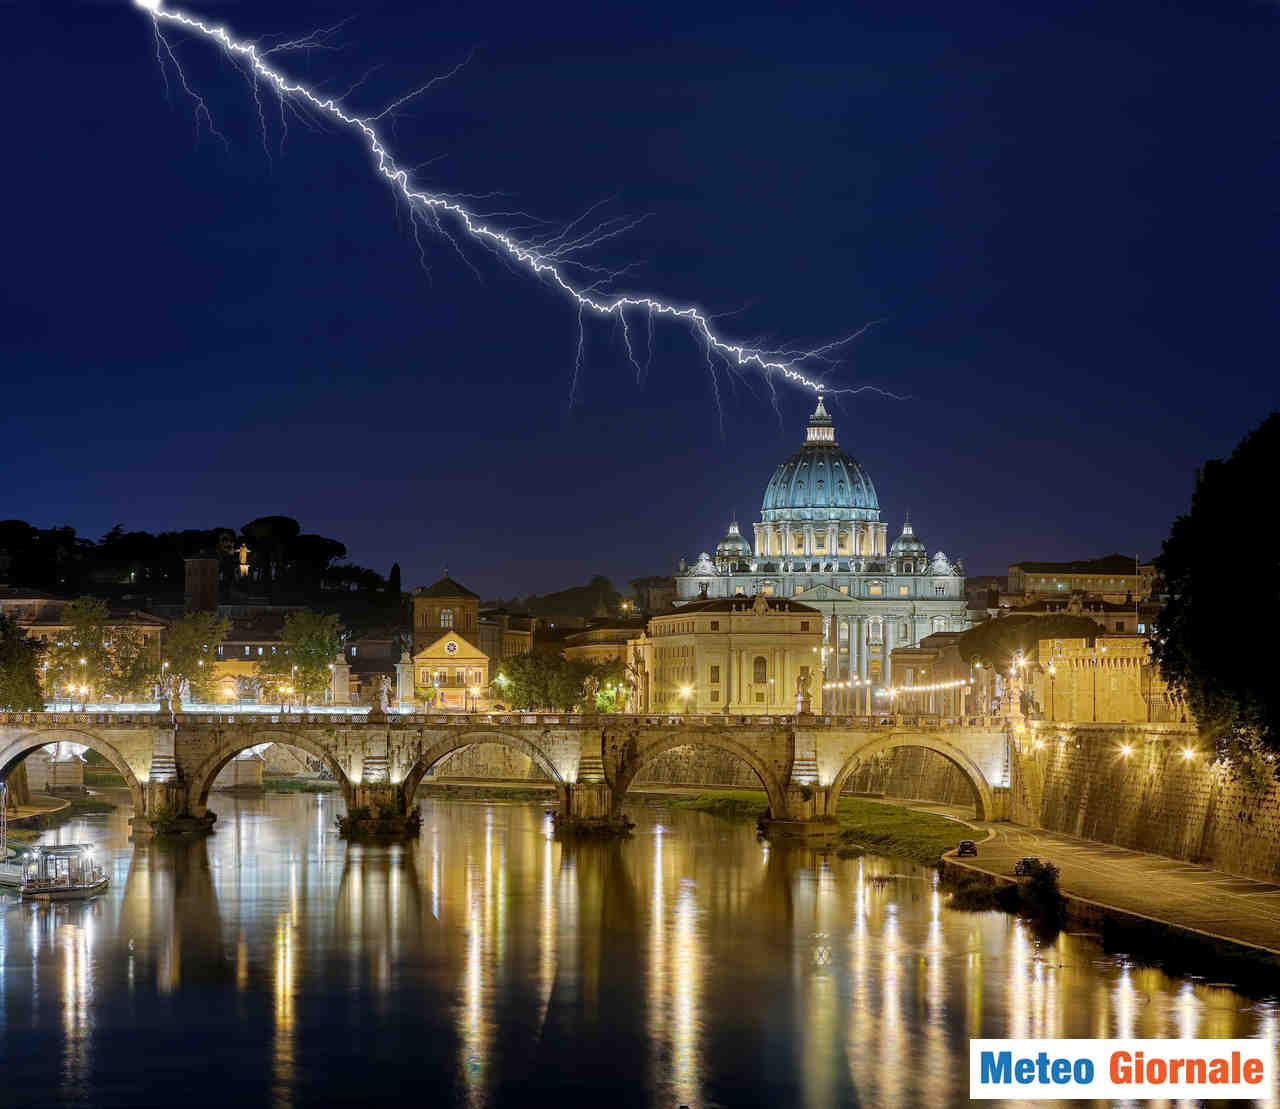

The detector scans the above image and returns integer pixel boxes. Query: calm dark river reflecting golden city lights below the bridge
[0,793,1277,1109]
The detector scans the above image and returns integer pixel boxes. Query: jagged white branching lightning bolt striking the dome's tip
[133,0,897,400]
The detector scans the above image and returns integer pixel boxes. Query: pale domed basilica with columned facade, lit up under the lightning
[676,397,969,685]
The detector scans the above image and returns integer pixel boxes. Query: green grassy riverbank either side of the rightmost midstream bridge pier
[675,790,973,864]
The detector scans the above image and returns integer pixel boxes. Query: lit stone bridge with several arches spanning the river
[0,711,1010,832]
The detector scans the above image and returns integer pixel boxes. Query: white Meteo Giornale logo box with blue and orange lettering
[969,1040,1275,1100]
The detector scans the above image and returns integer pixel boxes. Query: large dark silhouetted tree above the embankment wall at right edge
[1152,412,1280,757]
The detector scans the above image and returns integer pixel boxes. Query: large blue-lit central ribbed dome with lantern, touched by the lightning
[760,396,879,522]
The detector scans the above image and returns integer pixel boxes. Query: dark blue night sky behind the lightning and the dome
[0,0,1280,595]
